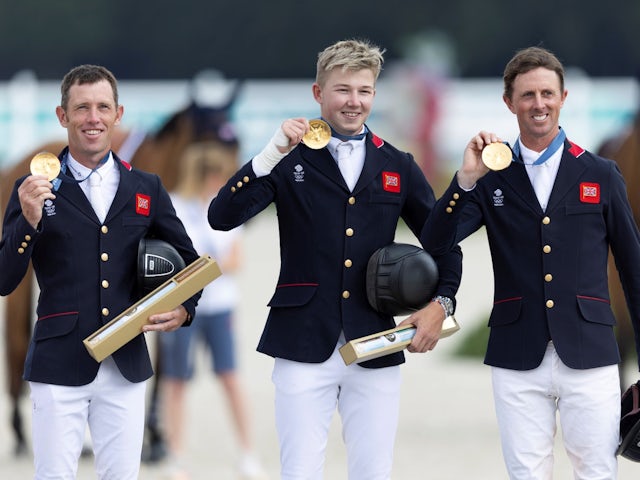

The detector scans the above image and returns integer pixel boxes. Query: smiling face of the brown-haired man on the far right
[503,67,567,152]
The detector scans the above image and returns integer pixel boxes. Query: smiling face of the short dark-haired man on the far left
[56,80,124,168]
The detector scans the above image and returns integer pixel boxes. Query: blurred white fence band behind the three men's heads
[0,72,640,175]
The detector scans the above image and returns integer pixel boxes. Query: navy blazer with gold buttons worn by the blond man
[208,133,462,367]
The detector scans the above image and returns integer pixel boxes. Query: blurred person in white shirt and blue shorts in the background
[160,141,266,480]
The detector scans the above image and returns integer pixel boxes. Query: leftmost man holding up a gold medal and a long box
[0,65,199,480]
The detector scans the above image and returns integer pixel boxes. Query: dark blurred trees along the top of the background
[0,0,640,80]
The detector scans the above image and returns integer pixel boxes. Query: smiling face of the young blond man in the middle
[312,68,376,135]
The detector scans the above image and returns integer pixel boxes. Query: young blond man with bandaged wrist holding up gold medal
[209,40,461,480]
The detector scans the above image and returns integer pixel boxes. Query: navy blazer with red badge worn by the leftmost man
[0,150,199,385]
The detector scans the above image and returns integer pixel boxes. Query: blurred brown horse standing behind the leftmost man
[0,84,240,461]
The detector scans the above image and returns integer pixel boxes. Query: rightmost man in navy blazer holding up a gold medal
[423,47,640,480]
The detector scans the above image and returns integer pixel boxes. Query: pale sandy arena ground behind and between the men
[0,212,640,480]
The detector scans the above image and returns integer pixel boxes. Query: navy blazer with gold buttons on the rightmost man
[424,141,640,370]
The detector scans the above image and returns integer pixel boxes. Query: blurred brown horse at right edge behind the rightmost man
[598,111,640,391]
